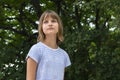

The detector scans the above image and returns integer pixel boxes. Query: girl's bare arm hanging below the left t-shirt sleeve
[26,57,37,80]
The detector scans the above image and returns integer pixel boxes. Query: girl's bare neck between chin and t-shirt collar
[43,36,58,49]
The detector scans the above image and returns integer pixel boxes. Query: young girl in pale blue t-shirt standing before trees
[26,10,71,80]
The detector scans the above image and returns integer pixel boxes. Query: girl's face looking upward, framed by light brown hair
[42,16,59,35]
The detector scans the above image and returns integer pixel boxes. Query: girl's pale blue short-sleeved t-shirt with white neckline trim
[26,42,71,80]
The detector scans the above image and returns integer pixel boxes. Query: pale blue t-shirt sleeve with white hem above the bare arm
[26,45,41,63]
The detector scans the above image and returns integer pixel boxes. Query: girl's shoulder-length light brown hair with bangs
[37,10,64,44]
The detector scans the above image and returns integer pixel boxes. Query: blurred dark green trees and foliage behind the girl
[0,0,120,80]
